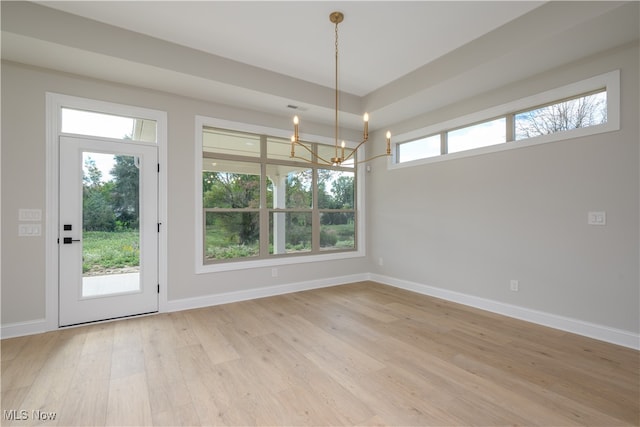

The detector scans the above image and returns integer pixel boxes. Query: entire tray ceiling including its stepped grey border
[2,1,638,134]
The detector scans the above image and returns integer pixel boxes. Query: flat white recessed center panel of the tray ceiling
[27,1,542,96]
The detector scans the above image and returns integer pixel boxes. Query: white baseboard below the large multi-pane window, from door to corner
[167,273,369,311]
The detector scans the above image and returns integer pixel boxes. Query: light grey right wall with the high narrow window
[367,44,640,335]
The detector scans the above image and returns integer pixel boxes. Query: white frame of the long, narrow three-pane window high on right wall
[388,69,620,170]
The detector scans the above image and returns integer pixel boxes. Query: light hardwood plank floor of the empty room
[2,282,640,426]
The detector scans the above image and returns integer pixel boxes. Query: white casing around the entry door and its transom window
[44,92,168,331]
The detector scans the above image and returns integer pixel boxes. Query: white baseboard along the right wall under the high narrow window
[369,274,640,350]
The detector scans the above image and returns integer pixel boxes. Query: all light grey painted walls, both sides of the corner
[1,44,640,344]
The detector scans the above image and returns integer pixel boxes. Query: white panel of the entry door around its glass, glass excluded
[58,136,159,326]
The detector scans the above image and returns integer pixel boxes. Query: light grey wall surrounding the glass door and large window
[2,62,367,326]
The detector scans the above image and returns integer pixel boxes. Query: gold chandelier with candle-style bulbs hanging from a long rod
[290,12,391,166]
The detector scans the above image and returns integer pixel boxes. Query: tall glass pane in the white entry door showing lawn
[82,152,140,297]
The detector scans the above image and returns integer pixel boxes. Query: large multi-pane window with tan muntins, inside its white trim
[199,125,357,264]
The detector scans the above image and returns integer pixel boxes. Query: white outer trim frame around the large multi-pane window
[194,115,366,274]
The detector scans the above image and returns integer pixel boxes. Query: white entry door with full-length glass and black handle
[58,137,158,326]
